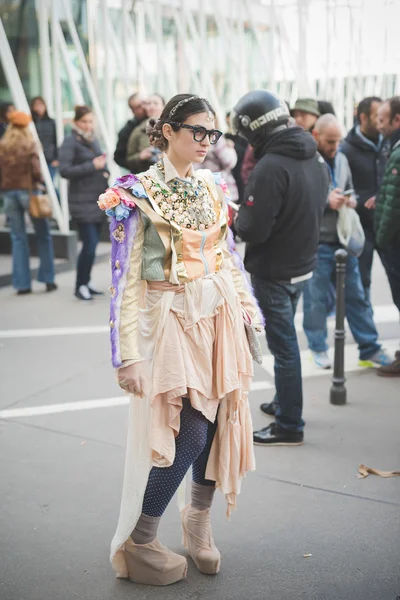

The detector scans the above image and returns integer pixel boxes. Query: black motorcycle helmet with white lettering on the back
[231,90,290,147]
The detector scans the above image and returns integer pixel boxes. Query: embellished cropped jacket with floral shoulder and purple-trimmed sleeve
[98,157,257,368]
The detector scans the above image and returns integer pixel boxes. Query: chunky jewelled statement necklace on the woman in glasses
[144,162,217,231]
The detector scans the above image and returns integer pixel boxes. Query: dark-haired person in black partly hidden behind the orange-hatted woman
[30,96,59,181]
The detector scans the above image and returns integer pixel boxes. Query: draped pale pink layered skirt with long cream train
[111,159,257,577]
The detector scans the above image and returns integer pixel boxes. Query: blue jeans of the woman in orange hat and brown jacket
[3,190,54,290]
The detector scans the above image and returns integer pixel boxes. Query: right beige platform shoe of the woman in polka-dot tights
[182,504,221,575]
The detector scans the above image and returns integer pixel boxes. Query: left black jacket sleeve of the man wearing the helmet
[235,165,288,244]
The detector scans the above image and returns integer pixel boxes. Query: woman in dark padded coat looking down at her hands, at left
[59,106,109,301]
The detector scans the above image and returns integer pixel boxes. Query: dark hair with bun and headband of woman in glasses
[146,94,215,151]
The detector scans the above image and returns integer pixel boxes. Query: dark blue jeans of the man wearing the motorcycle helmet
[251,275,305,431]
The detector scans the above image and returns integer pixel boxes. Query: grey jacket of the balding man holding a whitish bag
[319,152,353,244]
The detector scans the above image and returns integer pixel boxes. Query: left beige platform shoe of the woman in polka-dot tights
[124,538,187,585]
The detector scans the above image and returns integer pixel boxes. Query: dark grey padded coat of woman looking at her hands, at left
[58,131,109,223]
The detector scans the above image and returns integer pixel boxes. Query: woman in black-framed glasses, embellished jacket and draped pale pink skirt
[99,94,262,585]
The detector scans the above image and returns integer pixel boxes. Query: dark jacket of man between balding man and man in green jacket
[340,125,387,231]
